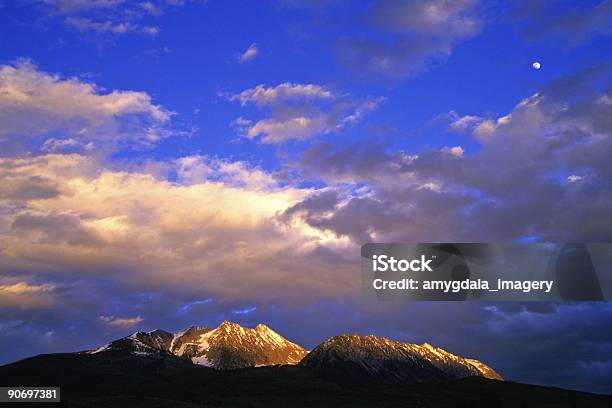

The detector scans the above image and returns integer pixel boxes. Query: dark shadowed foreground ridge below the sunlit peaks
[0,351,612,408]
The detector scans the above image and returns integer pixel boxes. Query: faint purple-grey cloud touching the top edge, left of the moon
[336,0,483,78]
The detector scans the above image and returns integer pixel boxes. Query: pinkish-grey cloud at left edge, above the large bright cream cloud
[0,61,172,150]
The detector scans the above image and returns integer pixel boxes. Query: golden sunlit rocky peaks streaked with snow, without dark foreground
[88,321,502,383]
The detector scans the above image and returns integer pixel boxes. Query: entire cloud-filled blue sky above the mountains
[0,0,612,393]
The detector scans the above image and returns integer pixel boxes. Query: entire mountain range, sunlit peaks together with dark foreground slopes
[0,322,612,408]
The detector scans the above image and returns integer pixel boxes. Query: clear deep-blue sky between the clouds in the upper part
[0,1,610,164]
